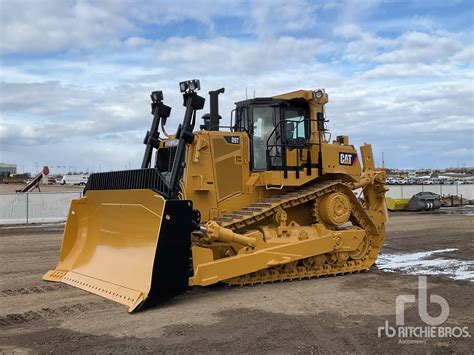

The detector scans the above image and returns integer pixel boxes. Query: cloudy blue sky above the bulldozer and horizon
[0,0,474,173]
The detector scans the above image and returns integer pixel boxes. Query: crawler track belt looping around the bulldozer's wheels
[211,182,385,285]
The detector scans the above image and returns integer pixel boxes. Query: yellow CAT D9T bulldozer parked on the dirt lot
[43,80,387,312]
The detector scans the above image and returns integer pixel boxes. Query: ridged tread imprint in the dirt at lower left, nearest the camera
[0,302,106,327]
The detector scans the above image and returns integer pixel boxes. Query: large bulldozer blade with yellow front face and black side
[43,189,194,312]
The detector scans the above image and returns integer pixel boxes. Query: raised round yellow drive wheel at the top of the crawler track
[315,192,352,226]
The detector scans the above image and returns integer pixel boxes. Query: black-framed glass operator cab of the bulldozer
[232,97,311,172]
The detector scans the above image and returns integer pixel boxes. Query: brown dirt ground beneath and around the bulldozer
[0,213,474,353]
